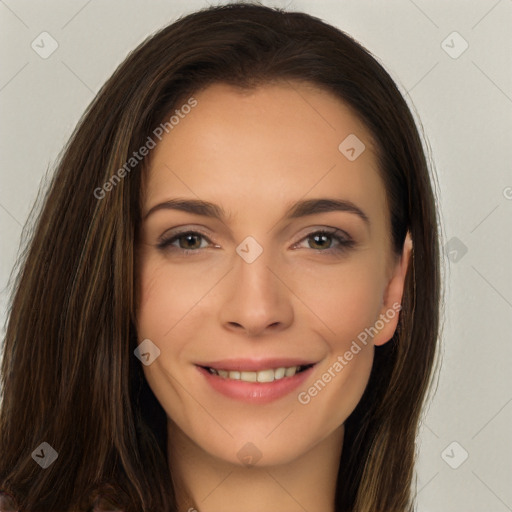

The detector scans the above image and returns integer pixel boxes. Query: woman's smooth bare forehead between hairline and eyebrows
[143,82,386,228]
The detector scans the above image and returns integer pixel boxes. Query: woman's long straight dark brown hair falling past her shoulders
[0,4,440,512]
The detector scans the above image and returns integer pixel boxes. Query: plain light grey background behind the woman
[0,0,512,512]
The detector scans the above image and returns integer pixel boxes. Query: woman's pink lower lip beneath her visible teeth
[196,365,315,404]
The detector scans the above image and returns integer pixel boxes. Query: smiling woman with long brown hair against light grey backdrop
[0,4,440,512]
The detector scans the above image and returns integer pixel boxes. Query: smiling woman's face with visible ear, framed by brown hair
[137,82,409,465]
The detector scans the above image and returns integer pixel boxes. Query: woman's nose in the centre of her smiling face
[219,250,294,336]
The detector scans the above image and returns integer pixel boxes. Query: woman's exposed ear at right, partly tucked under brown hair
[373,232,413,346]
